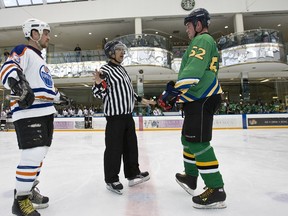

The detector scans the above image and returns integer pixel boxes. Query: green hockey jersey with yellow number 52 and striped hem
[175,33,222,103]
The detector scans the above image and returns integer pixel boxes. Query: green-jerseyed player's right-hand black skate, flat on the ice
[192,188,226,209]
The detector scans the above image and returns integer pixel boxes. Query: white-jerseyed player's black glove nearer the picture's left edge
[8,69,35,109]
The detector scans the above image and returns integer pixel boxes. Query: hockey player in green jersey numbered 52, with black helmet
[160,8,226,208]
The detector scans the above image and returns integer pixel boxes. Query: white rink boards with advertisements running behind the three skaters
[3,113,288,131]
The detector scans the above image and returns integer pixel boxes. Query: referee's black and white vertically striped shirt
[92,62,142,116]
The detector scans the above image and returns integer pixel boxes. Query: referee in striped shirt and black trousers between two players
[92,41,153,194]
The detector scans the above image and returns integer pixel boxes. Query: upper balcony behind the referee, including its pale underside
[46,34,177,83]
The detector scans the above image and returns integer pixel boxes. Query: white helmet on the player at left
[22,19,51,38]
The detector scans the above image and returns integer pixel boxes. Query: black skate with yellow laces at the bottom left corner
[12,190,40,216]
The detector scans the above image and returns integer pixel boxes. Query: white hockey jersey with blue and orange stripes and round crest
[0,45,60,121]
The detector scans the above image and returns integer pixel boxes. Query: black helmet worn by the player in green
[184,8,210,27]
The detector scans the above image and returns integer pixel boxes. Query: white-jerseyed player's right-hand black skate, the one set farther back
[29,180,49,209]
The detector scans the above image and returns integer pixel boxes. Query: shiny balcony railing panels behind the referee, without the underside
[46,34,173,77]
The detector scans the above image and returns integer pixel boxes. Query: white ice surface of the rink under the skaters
[0,129,288,216]
